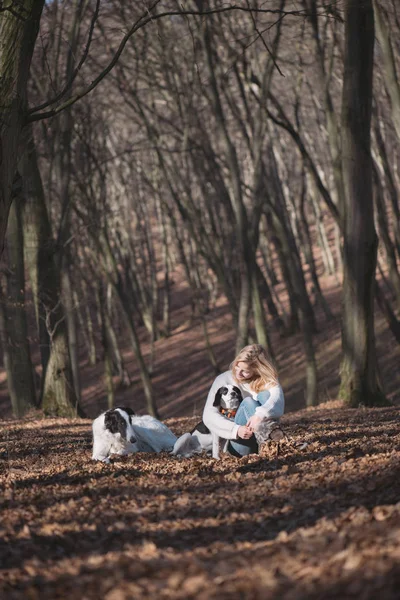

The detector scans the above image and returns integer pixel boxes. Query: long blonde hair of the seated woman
[230,344,278,392]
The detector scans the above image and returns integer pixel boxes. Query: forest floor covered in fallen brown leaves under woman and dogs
[0,401,400,600]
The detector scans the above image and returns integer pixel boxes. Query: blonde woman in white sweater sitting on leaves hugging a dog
[203,344,285,456]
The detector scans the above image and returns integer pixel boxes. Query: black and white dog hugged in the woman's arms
[173,384,243,456]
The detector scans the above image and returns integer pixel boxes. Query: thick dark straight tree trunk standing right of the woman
[340,0,386,406]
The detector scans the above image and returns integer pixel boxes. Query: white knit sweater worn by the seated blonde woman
[203,371,285,440]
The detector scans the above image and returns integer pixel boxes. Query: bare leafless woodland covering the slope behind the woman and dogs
[0,0,400,417]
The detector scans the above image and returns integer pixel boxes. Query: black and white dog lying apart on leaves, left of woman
[92,407,177,463]
